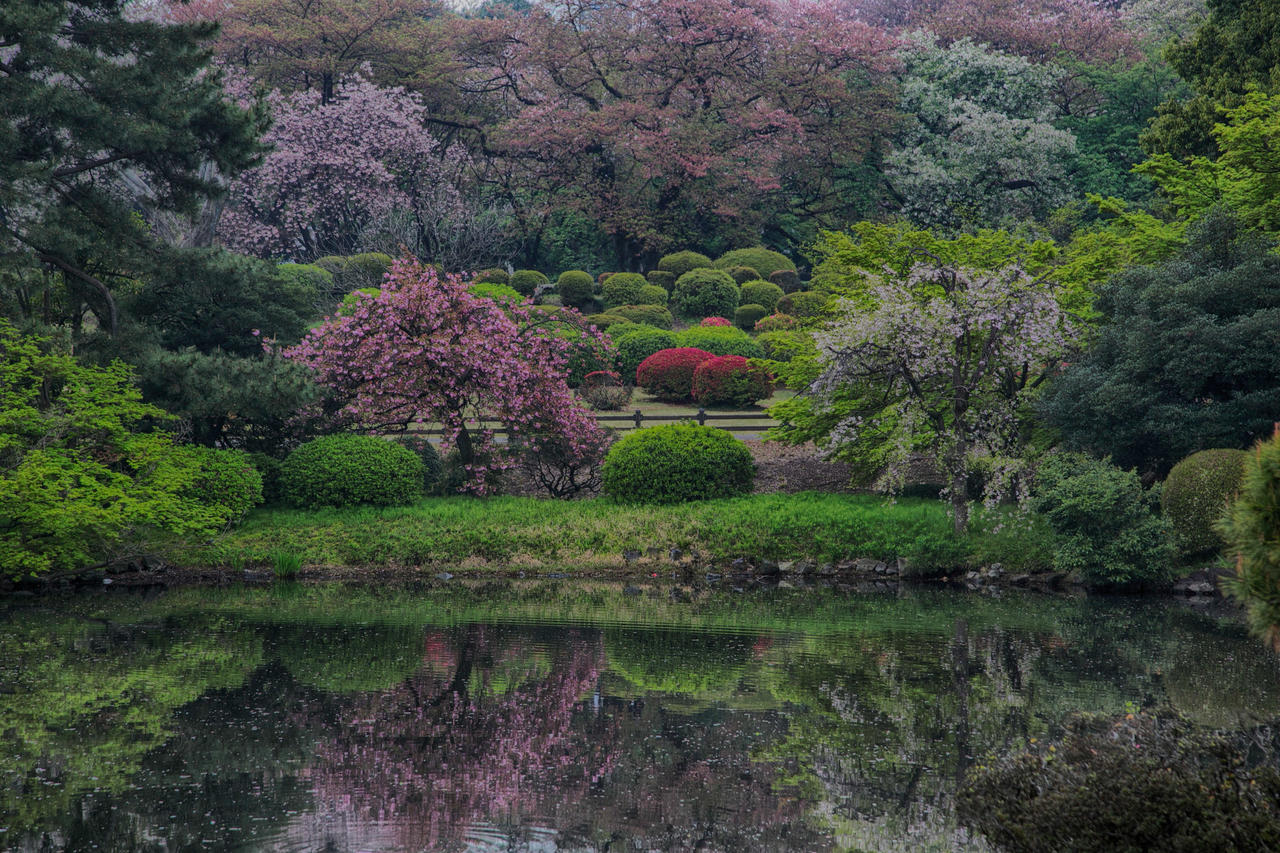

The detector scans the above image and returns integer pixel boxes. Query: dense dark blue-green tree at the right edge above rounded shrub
[1041,211,1280,474]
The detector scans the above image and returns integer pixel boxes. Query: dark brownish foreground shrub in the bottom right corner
[956,715,1280,853]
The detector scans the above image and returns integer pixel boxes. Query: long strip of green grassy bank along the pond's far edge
[189,493,1048,571]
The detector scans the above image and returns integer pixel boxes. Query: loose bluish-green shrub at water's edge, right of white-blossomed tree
[1032,453,1174,584]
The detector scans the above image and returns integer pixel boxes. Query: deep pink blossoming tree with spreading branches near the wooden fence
[285,259,605,494]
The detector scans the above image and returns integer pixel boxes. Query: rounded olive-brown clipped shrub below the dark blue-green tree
[1160,450,1249,557]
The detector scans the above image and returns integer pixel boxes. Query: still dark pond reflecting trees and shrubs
[0,580,1280,850]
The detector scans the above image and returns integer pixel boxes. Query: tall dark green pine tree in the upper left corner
[0,0,262,334]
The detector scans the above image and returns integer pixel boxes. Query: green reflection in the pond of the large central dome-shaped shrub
[604,629,751,697]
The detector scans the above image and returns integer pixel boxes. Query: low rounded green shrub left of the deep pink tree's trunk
[280,435,424,507]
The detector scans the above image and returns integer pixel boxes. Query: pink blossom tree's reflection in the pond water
[310,626,611,849]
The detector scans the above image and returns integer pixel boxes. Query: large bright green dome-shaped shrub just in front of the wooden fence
[602,424,755,503]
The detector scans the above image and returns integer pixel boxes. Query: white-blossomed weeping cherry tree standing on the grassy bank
[810,261,1075,534]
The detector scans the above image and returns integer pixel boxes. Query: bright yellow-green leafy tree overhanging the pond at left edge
[0,321,234,578]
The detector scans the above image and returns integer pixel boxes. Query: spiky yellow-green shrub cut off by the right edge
[1219,433,1280,649]
